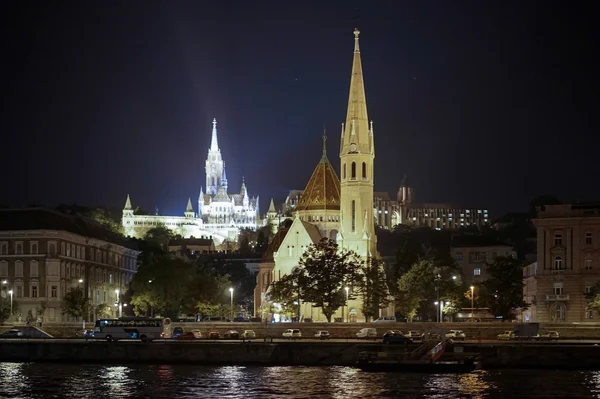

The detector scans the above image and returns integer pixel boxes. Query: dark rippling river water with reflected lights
[0,363,600,399]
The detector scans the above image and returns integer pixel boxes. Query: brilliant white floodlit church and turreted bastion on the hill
[122,119,260,246]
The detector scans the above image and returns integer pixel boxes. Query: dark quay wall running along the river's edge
[0,340,600,370]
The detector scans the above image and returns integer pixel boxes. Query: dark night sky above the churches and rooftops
[0,0,600,216]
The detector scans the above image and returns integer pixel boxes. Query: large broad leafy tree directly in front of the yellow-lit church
[297,238,362,322]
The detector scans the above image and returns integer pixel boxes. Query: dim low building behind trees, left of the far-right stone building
[450,235,517,286]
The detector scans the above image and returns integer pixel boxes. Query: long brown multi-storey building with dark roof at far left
[0,208,140,322]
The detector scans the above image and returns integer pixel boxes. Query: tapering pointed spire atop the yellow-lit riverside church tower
[340,29,372,154]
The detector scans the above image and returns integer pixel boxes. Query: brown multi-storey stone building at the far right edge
[523,203,600,322]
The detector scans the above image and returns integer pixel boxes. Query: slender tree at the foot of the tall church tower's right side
[356,258,390,321]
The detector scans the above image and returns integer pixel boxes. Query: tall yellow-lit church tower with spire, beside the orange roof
[338,29,377,257]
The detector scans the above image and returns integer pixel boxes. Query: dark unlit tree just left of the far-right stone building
[480,256,529,320]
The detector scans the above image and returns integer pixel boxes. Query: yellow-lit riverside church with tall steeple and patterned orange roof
[254,30,378,321]
